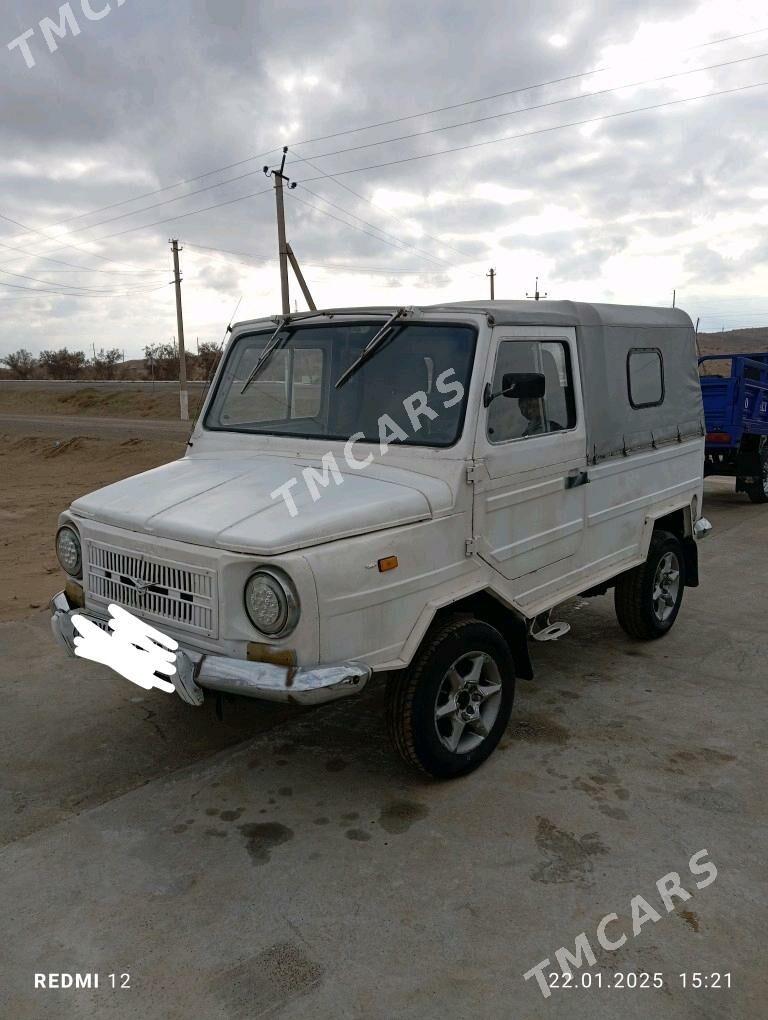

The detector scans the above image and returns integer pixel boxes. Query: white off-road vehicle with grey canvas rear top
[52,301,710,776]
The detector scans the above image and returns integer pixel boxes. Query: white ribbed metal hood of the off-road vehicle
[71,455,452,556]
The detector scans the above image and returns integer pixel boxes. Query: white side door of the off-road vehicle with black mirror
[473,326,587,590]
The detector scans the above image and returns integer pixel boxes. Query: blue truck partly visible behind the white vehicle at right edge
[699,354,768,503]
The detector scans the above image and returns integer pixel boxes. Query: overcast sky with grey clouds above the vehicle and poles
[0,0,768,357]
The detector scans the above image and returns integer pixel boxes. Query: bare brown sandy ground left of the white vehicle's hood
[0,435,185,620]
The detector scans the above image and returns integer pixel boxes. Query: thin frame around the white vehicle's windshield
[202,315,479,451]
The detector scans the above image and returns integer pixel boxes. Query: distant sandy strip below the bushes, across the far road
[0,384,202,418]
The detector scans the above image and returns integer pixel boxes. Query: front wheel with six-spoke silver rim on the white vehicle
[387,618,515,779]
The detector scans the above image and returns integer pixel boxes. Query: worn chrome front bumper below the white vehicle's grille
[51,592,371,705]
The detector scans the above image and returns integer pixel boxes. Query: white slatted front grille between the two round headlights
[86,542,216,638]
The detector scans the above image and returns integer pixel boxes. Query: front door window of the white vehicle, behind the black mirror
[488,340,576,443]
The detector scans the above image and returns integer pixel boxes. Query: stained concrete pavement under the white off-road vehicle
[0,480,768,1020]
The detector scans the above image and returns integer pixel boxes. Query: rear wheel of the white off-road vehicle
[614,531,685,641]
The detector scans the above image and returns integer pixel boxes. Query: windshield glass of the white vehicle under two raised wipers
[205,320,476,447]
